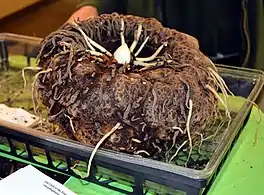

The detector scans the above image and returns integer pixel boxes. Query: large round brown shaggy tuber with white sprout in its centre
[35,13,228,167]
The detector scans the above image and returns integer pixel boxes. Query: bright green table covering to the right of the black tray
[208,108,264,195]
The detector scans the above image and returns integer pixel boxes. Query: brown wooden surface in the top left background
[0,0,78,37]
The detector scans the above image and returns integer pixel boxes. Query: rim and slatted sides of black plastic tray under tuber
[0,34,263,195]
